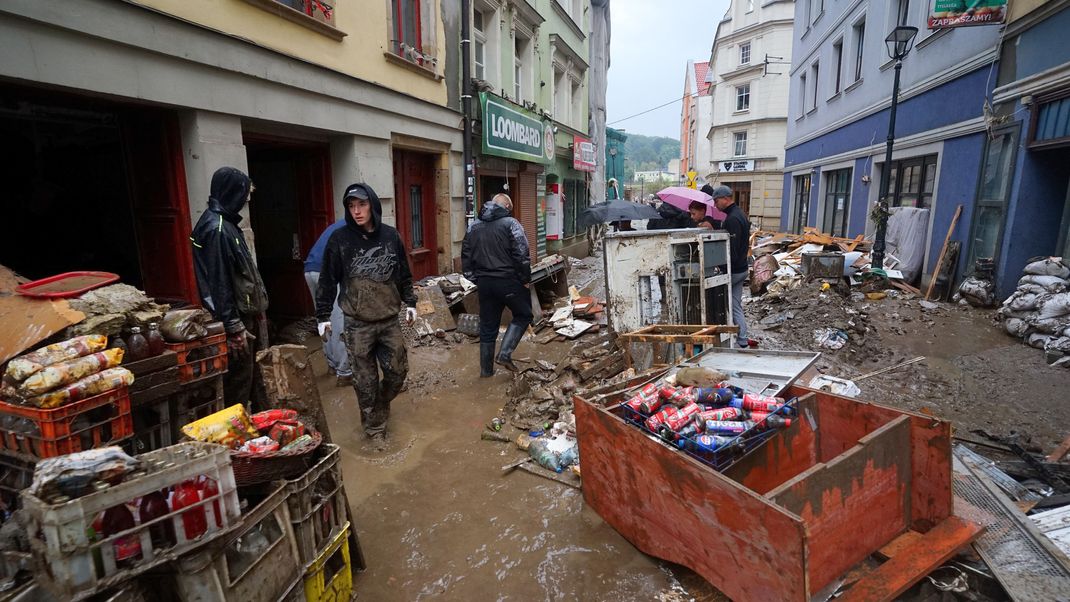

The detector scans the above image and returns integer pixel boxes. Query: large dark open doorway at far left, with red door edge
[0,87,197,302]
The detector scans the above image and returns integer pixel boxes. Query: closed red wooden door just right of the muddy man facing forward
[394,151,439,280]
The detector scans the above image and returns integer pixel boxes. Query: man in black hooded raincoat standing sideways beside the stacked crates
[189,167,268,406]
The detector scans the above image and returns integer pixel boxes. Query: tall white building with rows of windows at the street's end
[702,0,795,229]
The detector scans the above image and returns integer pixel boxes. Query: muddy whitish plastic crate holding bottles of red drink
[22,442,241,600]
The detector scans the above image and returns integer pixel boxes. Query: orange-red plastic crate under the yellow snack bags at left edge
[0,387,134,458]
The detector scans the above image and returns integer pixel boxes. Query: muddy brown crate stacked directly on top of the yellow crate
[286,444,349,565]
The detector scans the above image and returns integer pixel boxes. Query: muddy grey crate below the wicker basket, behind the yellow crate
[172,487,305,602]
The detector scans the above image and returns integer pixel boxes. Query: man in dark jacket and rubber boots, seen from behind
[461,195,532,377]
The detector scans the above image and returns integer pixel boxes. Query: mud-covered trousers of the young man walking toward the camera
[346,315,409,436]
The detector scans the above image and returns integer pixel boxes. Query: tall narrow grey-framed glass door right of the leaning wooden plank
[967,126,1019,269]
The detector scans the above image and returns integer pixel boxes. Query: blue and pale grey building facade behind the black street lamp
[781,0,999,292]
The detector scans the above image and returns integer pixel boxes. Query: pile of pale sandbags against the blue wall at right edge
[996,257,1070,367]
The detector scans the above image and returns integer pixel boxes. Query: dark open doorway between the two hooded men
[244,135,335,322]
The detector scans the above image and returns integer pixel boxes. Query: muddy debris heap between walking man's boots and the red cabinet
[504,328,625,430]
